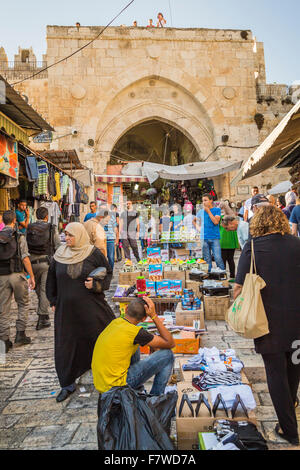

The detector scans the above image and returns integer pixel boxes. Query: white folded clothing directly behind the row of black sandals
[209,384,256,410]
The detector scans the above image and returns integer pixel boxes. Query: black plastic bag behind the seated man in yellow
[97,386,177,450]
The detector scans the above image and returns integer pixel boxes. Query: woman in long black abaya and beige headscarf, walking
[46,222,115,402]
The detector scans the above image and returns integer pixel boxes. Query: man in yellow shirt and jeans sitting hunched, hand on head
[92,297,175,396]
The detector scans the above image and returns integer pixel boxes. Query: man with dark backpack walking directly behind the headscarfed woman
[26,207,61,330]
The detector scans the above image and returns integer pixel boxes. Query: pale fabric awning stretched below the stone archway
[142,160,243,184]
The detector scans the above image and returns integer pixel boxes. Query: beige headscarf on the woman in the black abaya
[54,222,94,264]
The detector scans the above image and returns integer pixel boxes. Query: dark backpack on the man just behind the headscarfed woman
[26,222,54,256]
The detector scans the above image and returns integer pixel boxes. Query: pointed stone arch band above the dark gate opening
[90,77,215,173]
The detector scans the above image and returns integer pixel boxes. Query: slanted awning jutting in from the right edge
[231,101,300,186]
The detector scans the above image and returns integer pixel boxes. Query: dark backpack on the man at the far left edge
[0,230,23,275]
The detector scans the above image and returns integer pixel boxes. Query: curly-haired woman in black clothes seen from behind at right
[234,206,300,445]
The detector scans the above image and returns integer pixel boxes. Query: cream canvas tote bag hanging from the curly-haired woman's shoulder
[225,240,270,339]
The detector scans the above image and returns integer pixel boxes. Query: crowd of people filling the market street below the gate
[0,182,300,444]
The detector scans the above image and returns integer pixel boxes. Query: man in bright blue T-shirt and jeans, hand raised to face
[197,194,225,272]
